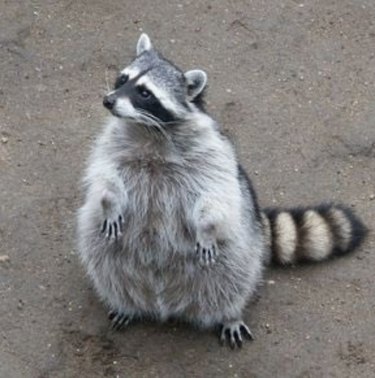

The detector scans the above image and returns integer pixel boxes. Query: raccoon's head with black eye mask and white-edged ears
[103,34,207,126]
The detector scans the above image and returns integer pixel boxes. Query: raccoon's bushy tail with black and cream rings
[261,204,368,265]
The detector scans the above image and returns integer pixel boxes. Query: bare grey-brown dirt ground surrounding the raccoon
[0,0,375,378]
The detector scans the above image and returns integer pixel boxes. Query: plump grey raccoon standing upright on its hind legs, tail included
[78,34,366,348]
